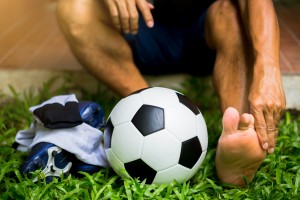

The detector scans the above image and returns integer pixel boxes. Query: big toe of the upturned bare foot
[223,107,240,134]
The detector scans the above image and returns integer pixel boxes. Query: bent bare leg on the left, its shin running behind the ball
[57,0,148,96]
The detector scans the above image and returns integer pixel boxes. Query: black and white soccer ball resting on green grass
[104,87,208,184]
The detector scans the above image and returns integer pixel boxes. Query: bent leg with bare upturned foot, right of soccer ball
[206,0,266,185]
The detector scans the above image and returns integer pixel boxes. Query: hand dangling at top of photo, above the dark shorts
[104,0,154,34]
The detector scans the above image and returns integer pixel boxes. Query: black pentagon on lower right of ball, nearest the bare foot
[179,136,202,169]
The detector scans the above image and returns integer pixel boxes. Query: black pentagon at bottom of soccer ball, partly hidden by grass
[124,159,157,184]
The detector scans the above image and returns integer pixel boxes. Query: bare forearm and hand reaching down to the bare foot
[238,0,285,153]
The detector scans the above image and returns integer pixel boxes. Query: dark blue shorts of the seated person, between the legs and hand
[125,12,215,76]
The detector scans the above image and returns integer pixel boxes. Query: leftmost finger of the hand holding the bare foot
[252,110,269,150]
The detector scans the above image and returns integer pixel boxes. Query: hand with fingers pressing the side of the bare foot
[249,66,286,153]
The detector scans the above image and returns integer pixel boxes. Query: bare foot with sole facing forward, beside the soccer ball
[216,108,266,186]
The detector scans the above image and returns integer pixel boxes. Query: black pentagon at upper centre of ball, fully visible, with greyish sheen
[131,105,165,136]
